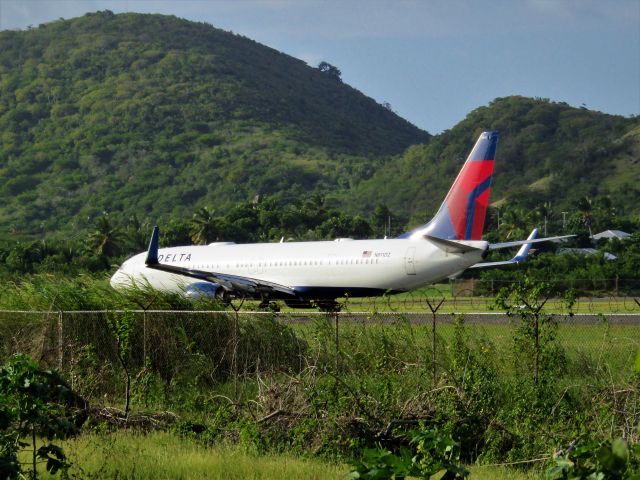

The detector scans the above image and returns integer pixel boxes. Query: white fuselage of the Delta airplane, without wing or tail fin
[111,238,487,298]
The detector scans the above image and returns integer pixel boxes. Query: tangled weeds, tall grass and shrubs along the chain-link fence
[0,279,640,479]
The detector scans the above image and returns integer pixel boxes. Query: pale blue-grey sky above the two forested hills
[0,0,640,134]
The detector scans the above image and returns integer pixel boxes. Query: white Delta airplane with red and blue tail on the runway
[111,131,571,310]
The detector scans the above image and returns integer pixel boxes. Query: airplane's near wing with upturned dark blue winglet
[145,226,297,296]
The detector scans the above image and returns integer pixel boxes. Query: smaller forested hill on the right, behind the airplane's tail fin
[345,97,640,228]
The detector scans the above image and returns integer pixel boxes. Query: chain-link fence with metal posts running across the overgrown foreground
[0,311,640,399]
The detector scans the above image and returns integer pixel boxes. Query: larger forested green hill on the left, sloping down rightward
[0,12,429,234]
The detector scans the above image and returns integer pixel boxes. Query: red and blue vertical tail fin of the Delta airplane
[400,132,498,240]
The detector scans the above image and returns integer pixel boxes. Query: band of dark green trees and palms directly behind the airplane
[0,196,640,294]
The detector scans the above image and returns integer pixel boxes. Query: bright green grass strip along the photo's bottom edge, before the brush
[32,432,541,480]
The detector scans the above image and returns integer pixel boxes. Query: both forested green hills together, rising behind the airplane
[0,11,640,244]
